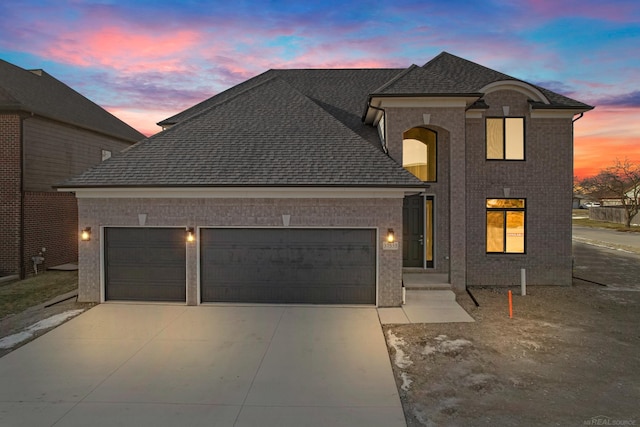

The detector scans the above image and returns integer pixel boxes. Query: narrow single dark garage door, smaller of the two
[104,228,186,302]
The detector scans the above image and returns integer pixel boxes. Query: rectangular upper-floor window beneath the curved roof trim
[487,117,524,160]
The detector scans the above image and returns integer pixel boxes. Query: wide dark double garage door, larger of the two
[200,228,376,304]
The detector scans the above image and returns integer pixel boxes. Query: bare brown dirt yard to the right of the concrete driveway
[385,280,640,426]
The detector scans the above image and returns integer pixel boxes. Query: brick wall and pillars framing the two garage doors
[78,197,402,307]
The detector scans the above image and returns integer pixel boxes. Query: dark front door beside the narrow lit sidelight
[402,194,424,267]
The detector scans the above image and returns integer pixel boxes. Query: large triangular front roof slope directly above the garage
[64,77,424,187]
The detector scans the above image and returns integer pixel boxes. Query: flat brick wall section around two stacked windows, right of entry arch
[465,91,573,286]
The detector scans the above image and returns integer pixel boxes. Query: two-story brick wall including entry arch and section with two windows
[372,90,573,289]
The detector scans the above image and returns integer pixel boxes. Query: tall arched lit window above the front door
[402,128,438,181]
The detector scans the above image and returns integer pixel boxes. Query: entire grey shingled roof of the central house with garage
[63,52,592,188]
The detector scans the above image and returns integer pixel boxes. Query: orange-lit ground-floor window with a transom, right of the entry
[486,199,525,254]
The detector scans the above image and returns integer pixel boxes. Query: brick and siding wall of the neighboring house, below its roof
[0,114,129,277]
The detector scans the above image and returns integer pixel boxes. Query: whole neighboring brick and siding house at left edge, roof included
[0,60,144,277]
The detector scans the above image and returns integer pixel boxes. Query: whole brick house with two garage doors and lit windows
[57,53,593,306]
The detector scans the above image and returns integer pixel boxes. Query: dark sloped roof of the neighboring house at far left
[0,60,144,142]
